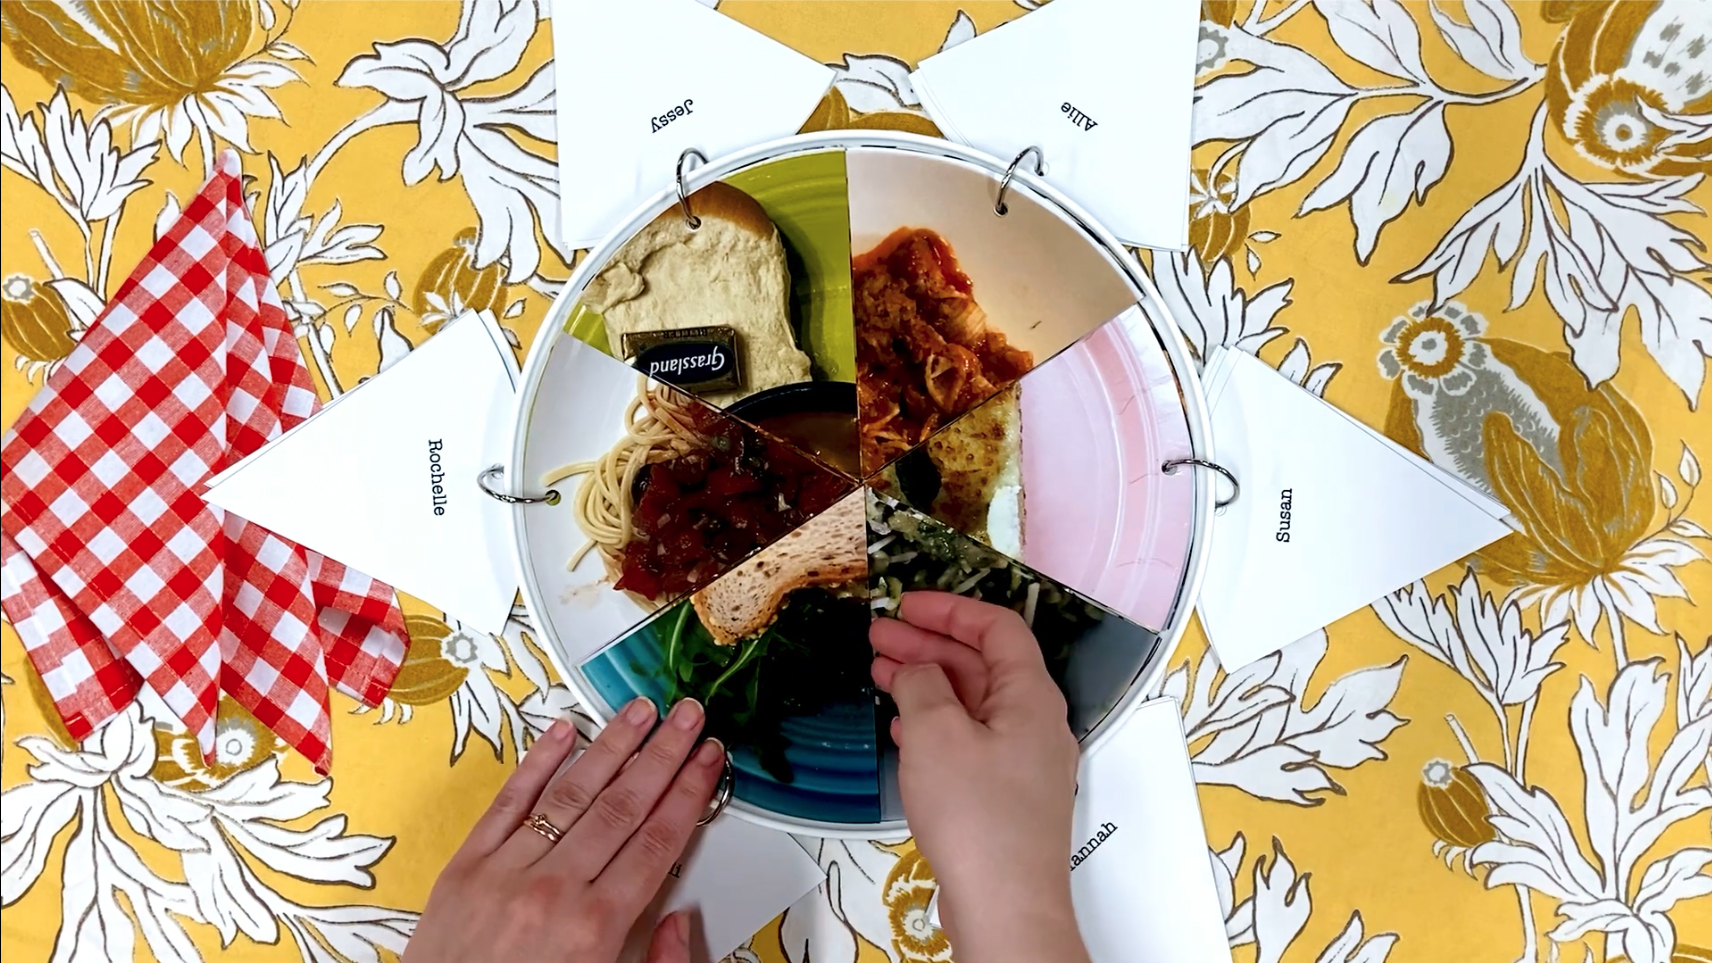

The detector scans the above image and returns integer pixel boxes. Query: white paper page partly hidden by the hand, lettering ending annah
[1070,697,1231,963]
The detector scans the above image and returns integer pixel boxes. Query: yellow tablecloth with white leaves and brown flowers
[0,0,1712,963]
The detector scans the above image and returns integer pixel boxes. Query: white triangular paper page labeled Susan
[1197,350,1510,668]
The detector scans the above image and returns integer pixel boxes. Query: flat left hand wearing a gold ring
[404,699,724,963]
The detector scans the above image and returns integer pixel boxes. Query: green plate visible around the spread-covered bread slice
[565,151,856,382]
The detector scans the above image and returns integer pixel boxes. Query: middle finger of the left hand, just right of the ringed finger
[553,699,707,873]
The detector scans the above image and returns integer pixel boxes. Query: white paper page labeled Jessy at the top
[553,0,832,250]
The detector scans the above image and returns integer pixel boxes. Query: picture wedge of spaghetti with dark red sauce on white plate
[515,339,856,663]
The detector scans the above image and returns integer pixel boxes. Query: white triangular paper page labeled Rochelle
[204,312,517,632]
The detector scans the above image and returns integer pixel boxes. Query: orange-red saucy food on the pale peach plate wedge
[851,228,1034,475]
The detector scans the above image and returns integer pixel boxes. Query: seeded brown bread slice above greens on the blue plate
[692,488,868,646]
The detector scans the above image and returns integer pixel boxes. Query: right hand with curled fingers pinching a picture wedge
[870,591,1087,963]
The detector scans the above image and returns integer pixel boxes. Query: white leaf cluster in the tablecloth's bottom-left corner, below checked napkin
[0,697,416,963]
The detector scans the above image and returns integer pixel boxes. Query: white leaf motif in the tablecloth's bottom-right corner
[1469,648,1712,963]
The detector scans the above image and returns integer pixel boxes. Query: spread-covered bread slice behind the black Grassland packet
[582,182,810,404]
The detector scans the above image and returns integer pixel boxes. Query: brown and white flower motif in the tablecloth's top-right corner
[1543,0,1712,176]
